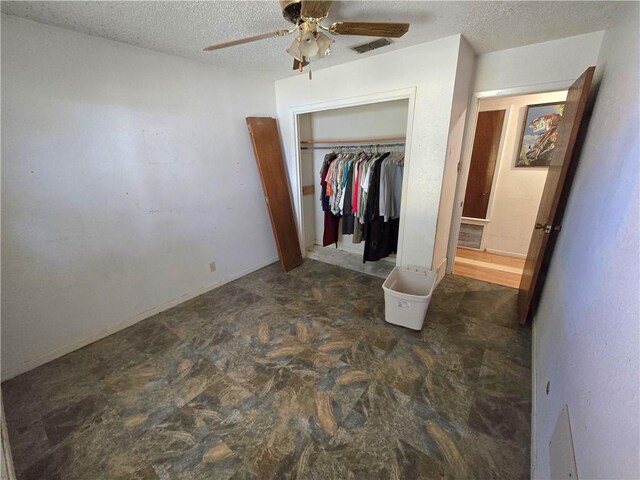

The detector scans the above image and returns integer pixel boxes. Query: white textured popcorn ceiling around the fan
[2,0,618,79]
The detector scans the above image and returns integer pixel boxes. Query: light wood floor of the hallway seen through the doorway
[453,247,525,288]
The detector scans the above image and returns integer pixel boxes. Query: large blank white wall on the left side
[2,15,276,378]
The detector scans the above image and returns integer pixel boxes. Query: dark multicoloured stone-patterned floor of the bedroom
[3,260,531,480]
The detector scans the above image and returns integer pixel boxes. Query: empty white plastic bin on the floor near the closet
[382,267,436,330]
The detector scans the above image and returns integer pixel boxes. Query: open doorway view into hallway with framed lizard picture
[453,91,567,288]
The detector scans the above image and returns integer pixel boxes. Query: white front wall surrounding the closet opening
[276,35,461,268]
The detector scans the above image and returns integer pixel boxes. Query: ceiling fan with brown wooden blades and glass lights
[204,0,409,71]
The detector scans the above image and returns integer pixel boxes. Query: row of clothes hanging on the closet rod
[320,152,404,262]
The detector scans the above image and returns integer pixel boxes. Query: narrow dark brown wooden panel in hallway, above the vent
[462,110,506,218]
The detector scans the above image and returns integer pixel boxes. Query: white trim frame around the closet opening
[288,87,416,265]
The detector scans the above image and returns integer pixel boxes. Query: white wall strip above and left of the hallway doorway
[447,32,604,271]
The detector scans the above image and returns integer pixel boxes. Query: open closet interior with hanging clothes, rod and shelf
[296,98,409,277]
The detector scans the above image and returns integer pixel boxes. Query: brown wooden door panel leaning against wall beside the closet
[247,117,302,272]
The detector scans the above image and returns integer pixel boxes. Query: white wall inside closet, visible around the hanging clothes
[304,100,409,255]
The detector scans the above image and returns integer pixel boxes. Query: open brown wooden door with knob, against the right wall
[518,67,595,323]
